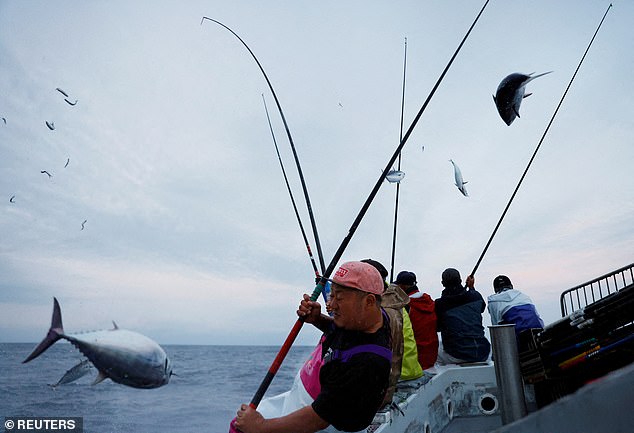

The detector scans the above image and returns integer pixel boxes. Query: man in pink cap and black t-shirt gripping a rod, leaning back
[235,262,392,433]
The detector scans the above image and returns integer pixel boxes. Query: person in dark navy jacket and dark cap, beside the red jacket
[435,268,491,365]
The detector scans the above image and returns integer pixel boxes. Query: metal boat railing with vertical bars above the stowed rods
[559,263,634,317]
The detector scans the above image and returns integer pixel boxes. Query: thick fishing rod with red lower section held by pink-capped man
[242,0,490,409]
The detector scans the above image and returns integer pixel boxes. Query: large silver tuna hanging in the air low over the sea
[22,298,172,388]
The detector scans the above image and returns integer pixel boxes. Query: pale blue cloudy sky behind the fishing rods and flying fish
[0,0,634,345]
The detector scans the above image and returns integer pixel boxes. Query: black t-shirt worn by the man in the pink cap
[312,316,392,431]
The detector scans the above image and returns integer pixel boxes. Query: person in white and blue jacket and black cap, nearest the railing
[487,275,544,336]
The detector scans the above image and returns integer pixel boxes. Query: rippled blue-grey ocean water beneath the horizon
[0,341,313,433]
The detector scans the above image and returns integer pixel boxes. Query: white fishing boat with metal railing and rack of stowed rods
[366,263,634,433]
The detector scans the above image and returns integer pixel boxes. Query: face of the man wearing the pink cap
[329,284,369,330]
